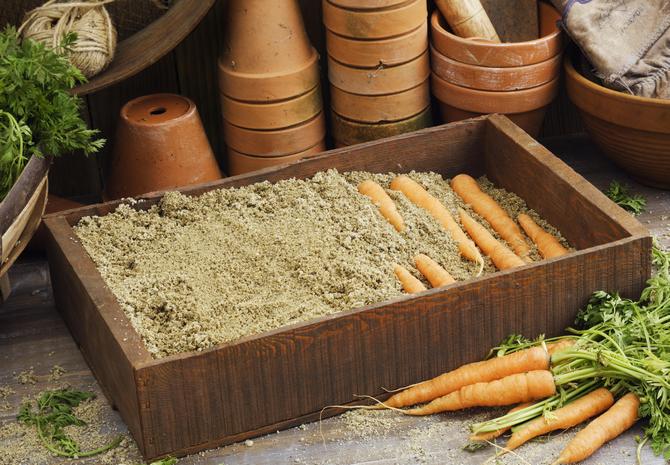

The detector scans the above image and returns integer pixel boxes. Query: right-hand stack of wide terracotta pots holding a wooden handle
[430,2,563,136]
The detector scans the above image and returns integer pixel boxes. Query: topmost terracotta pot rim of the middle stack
[322,0,428,39]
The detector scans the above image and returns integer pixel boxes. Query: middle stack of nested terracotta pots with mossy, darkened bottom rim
[323,0,431,146]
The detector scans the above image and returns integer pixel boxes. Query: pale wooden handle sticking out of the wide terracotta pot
[435,0,500,43]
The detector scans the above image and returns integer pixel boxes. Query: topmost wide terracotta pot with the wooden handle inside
[430,2,563,68]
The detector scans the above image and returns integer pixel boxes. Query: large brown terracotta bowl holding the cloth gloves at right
[564,51,670,189]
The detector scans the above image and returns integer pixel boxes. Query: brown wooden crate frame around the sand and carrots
[46,115,651,458]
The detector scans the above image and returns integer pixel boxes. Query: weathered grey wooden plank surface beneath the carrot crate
[0,132,670,465]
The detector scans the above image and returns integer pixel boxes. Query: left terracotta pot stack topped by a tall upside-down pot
[219,0,326,175]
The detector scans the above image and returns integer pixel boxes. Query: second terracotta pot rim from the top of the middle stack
[326,21,428,68]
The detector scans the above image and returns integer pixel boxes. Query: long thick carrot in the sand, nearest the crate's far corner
[451,174,530,261]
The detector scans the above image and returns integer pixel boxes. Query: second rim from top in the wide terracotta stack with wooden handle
[430,47,561,91]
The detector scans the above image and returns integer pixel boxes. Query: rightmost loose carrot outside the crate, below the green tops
[553,392,640,465]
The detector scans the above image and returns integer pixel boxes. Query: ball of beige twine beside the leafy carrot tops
[19,0,116,78]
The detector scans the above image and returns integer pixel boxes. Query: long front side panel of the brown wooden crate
[138,238,651,458]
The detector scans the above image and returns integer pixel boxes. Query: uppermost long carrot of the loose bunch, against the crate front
[384,347,549,407]
